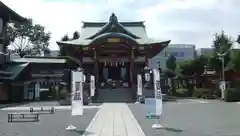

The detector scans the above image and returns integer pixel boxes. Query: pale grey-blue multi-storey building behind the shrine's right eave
[149,44,195,69]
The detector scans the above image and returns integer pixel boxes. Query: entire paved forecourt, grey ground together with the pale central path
[0,99,240,136]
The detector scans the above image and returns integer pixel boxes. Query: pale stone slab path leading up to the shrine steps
[83,103,145,136]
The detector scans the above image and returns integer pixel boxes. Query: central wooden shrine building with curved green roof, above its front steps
[57,13,170,98]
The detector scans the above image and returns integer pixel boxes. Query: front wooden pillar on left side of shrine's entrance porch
[93,48,99,97]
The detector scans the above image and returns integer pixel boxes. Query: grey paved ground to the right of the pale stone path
[129,99,240,136]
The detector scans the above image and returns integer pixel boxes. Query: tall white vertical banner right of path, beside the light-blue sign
[153,69,162,116]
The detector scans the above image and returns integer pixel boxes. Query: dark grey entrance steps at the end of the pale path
[96,88,133,103]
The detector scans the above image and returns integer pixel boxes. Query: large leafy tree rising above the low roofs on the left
[5,19,51,57]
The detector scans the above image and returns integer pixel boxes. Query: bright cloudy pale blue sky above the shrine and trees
[1,0,240,49]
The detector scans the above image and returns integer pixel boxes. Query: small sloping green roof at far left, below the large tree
[5,63,29,80]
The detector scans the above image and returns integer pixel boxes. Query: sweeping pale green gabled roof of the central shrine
[57,14,170,46]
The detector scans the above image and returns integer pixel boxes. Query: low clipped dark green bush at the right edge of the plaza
[224,88,240,102]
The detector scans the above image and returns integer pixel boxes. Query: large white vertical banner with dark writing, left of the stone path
[72,71,83,116]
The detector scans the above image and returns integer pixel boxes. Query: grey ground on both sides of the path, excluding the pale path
[0,100,240,136]
